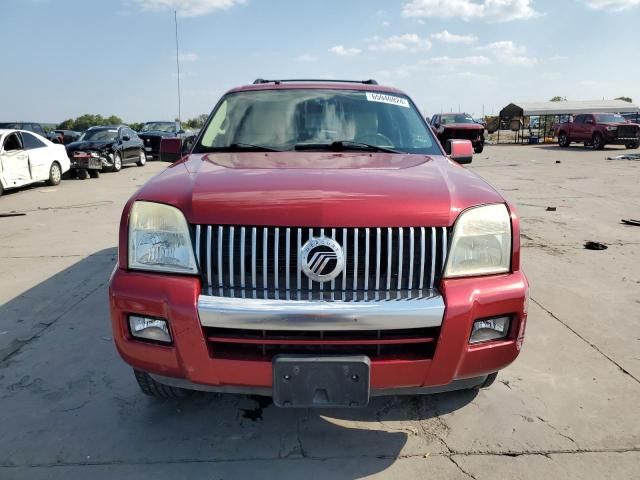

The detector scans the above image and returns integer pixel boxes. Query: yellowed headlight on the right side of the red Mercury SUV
[444,204,511,278]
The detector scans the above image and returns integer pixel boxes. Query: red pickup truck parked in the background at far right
[555,113,640,150]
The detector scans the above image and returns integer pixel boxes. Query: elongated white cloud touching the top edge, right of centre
[402,0,540,22]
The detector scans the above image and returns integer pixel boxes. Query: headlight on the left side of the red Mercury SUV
[129,202,198,273]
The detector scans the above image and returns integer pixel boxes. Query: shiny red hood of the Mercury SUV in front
[134,152,504,227]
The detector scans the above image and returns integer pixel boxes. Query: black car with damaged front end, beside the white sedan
[67,125,147,172]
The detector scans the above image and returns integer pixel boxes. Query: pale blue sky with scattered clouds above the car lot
[0,0,640,123]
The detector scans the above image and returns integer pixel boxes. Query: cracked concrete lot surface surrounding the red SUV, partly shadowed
[0,145,640,480]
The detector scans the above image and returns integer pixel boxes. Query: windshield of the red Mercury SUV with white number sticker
[194,89,441,155]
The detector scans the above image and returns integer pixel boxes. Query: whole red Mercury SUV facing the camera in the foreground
[109,80,528,407]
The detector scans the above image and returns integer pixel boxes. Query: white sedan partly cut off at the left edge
[0,130,71,195]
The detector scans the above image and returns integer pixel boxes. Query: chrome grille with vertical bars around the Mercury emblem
[195,225,448,296]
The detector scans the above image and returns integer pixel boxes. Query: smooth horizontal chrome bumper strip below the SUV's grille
[198,294,444,331]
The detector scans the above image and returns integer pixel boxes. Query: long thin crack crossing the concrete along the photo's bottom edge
[0,447,640,468]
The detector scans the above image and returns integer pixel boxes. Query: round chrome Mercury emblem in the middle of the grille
[300,237,344,283]
